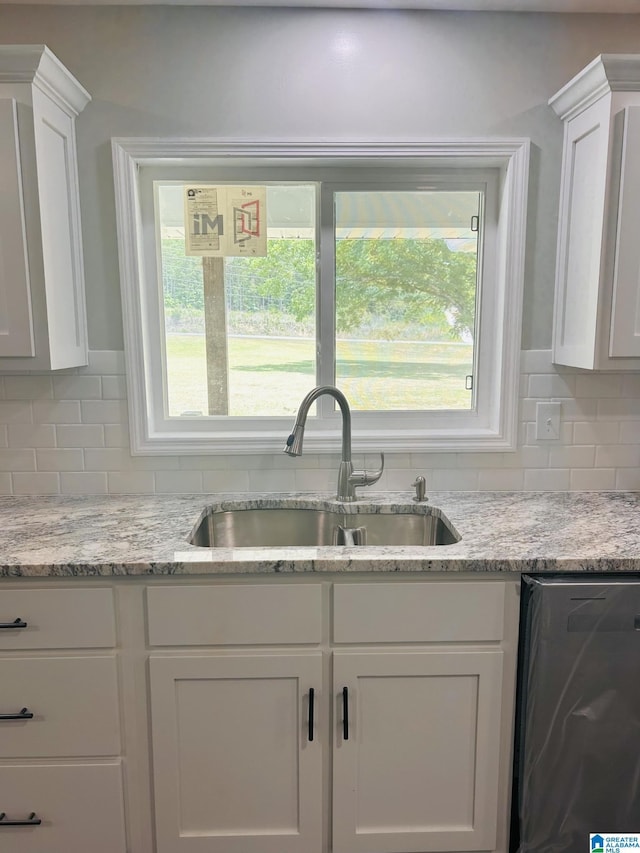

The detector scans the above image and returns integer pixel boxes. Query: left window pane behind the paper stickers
[156,183,316,417]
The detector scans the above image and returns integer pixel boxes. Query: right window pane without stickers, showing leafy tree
[334,190,481,411]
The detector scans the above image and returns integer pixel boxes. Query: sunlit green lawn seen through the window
[167,335,472,416]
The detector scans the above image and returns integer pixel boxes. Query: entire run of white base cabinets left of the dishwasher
[0,575,519,853]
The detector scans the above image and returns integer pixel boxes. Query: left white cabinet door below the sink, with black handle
[150,652,322,853]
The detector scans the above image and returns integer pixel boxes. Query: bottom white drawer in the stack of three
[0,761,127,853]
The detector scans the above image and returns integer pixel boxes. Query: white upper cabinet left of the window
[0,45,90,371]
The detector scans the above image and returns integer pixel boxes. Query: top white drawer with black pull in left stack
[0,588,116,653]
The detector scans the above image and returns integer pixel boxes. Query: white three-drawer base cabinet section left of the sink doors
[0,588,128,853]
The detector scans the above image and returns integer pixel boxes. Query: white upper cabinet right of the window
[549,54,640,370]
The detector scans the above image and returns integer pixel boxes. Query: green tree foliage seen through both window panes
[162,238,476,339]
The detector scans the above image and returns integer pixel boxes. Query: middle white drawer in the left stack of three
[0,656,120,756]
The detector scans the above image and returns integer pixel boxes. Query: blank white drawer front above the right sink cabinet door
[333,581,505,643]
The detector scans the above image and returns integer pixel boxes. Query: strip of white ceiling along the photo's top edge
[0,0,640,9]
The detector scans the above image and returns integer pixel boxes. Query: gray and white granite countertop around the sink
[0,492,640,578]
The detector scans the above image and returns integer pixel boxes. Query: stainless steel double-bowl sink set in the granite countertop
[189,507,460,548]
